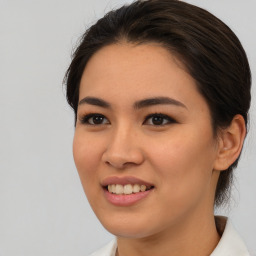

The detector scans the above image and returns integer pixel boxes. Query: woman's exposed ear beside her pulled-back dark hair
[214,115,246,171]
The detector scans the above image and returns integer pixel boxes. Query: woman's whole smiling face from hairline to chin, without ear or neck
[73,43,220,238]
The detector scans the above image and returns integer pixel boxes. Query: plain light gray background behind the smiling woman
[0,0,256,256]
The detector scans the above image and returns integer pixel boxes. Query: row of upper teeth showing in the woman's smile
[108,184,152,195]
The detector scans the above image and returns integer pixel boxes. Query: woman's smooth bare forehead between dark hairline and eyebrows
[79,43,204,111]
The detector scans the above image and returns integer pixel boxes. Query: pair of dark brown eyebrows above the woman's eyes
[78,96,187,110]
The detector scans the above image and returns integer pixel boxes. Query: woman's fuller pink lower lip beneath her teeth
[104,189,154,206]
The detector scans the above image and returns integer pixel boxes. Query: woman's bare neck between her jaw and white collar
[117,214,220,256]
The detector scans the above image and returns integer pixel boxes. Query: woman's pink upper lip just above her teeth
[101,176,154,187]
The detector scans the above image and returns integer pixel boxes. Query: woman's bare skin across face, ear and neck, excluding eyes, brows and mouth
[73,43,245,256]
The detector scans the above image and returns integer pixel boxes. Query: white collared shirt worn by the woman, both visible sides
[90,216,250,256]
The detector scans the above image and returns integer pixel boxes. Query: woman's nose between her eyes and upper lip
[102,124,144,169]
